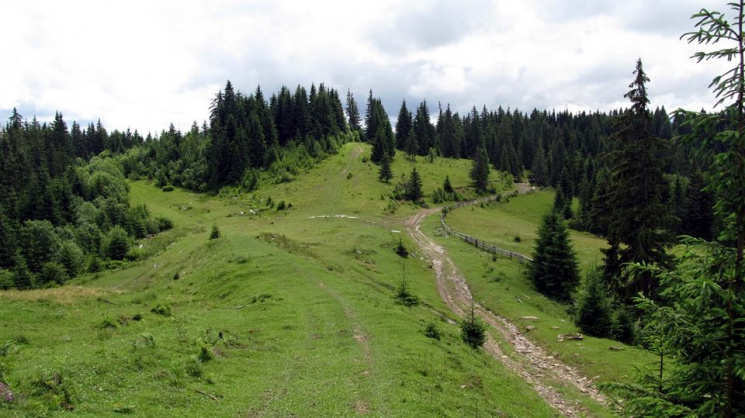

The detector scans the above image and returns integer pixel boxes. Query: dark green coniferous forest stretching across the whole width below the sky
[0,3,745,416]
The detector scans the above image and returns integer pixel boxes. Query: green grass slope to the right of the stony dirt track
[422,192,655,382]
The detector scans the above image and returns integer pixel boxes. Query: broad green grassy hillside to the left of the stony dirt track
[0,144,554,416]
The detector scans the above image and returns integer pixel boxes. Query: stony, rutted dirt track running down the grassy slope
[406,192,605,417]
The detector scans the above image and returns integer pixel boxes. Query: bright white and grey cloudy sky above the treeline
[0,0,729,133]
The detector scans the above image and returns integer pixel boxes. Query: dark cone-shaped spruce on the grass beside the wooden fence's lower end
[528,211,579,300]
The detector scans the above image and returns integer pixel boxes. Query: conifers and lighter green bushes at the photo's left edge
[0,110,171,289]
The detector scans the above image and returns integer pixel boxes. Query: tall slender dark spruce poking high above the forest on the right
[601,59,673,301]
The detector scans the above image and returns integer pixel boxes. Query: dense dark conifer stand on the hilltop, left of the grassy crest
[121,81,352,192]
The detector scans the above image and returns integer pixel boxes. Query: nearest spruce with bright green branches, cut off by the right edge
[609,4,745,417]
